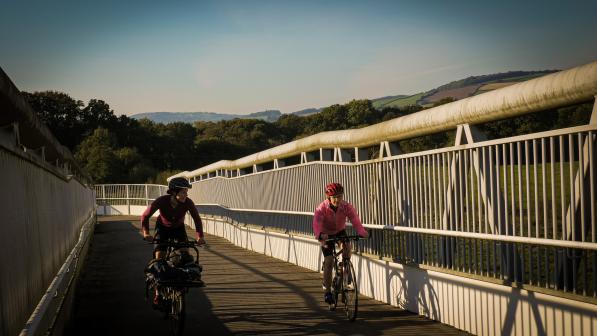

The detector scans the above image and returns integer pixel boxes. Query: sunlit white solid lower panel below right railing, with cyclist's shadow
[203,217,597,336]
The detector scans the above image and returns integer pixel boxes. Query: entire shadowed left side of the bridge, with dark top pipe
[0,69,95,335]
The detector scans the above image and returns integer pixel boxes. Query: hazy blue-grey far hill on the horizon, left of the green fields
[131,110,282,124]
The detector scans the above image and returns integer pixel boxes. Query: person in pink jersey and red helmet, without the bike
[313,183,369,303]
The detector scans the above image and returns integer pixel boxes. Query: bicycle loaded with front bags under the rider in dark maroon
[145,239,205,336]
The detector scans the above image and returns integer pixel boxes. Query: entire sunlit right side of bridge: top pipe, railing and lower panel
[176,62,597,335]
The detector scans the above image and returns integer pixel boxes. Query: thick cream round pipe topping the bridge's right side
[170,62,597,178]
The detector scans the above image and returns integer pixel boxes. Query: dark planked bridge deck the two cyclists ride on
[71,217,465,335]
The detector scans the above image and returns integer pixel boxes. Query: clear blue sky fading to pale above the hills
[0,0,597,115]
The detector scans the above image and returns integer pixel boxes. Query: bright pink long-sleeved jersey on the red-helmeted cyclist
[313,199,366,238]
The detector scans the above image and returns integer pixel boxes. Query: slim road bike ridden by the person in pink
[325,236,362,321]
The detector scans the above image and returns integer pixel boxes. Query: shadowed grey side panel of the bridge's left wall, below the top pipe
[0,147,95,335]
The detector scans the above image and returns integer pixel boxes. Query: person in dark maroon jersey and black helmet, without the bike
[141,177,205,261]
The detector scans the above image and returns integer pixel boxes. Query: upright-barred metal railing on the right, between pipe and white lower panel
[191,125,597,297]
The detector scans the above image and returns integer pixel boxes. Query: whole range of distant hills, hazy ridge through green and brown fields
[131,70,558,123]
